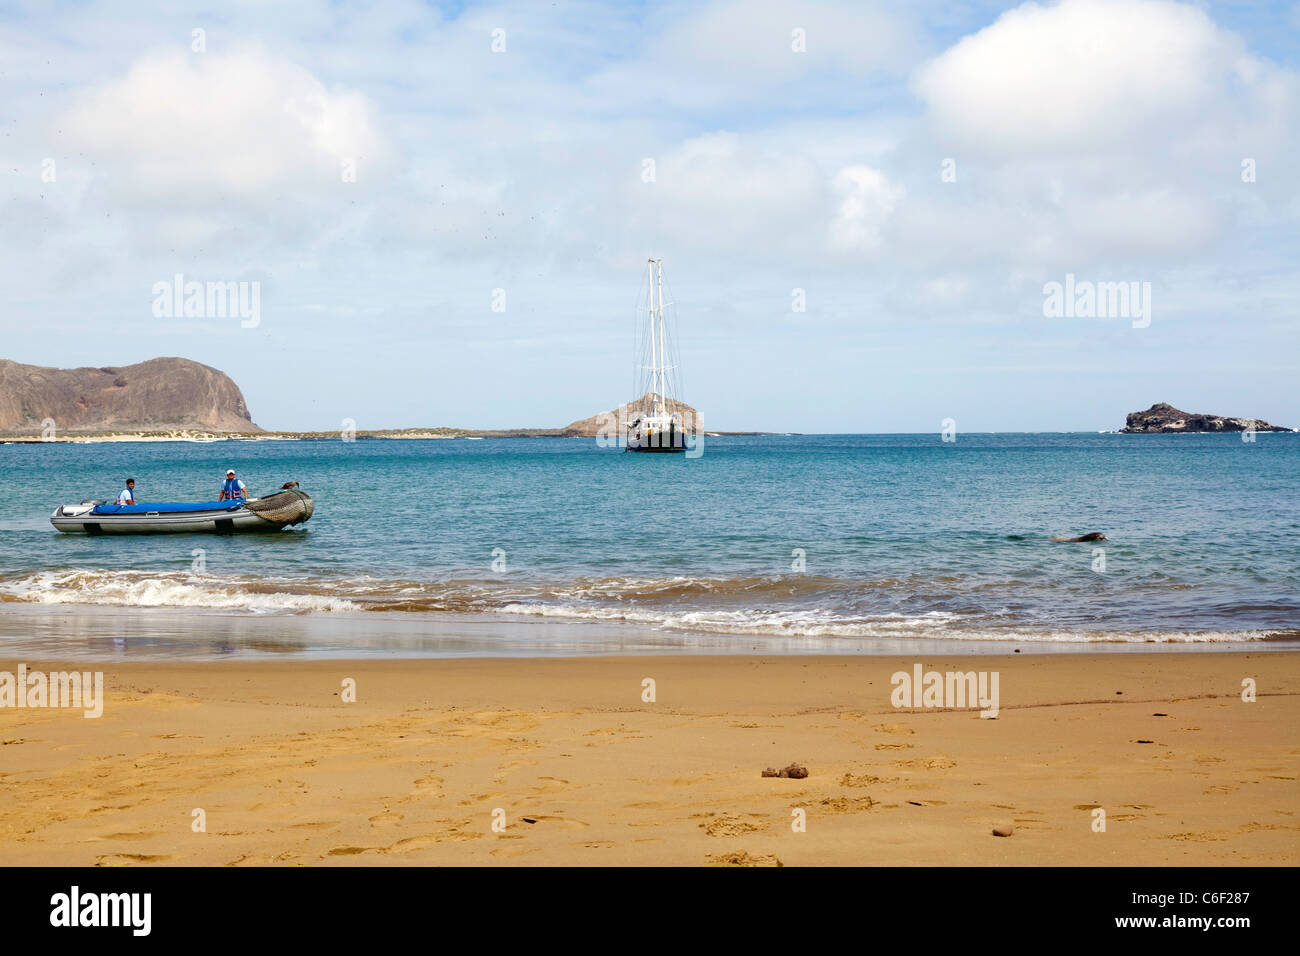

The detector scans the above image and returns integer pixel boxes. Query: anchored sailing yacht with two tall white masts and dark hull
[623,259,696,451]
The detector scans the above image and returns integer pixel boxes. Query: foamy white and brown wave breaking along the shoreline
[0,570,1300,644]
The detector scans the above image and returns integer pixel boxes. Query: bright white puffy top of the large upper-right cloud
[915,0,1251,152]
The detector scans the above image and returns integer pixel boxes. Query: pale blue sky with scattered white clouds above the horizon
[0,0,1300,432]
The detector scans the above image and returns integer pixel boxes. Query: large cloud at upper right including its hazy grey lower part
[900,0,1300,272]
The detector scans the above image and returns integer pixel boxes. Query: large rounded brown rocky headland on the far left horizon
[0,359,261,433]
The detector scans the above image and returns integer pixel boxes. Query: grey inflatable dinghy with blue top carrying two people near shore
[49,489,315,535]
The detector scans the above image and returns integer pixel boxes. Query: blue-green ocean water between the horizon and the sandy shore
[0,433,1300,649]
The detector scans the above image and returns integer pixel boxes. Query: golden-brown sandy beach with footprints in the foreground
[0,652,1300,866]
